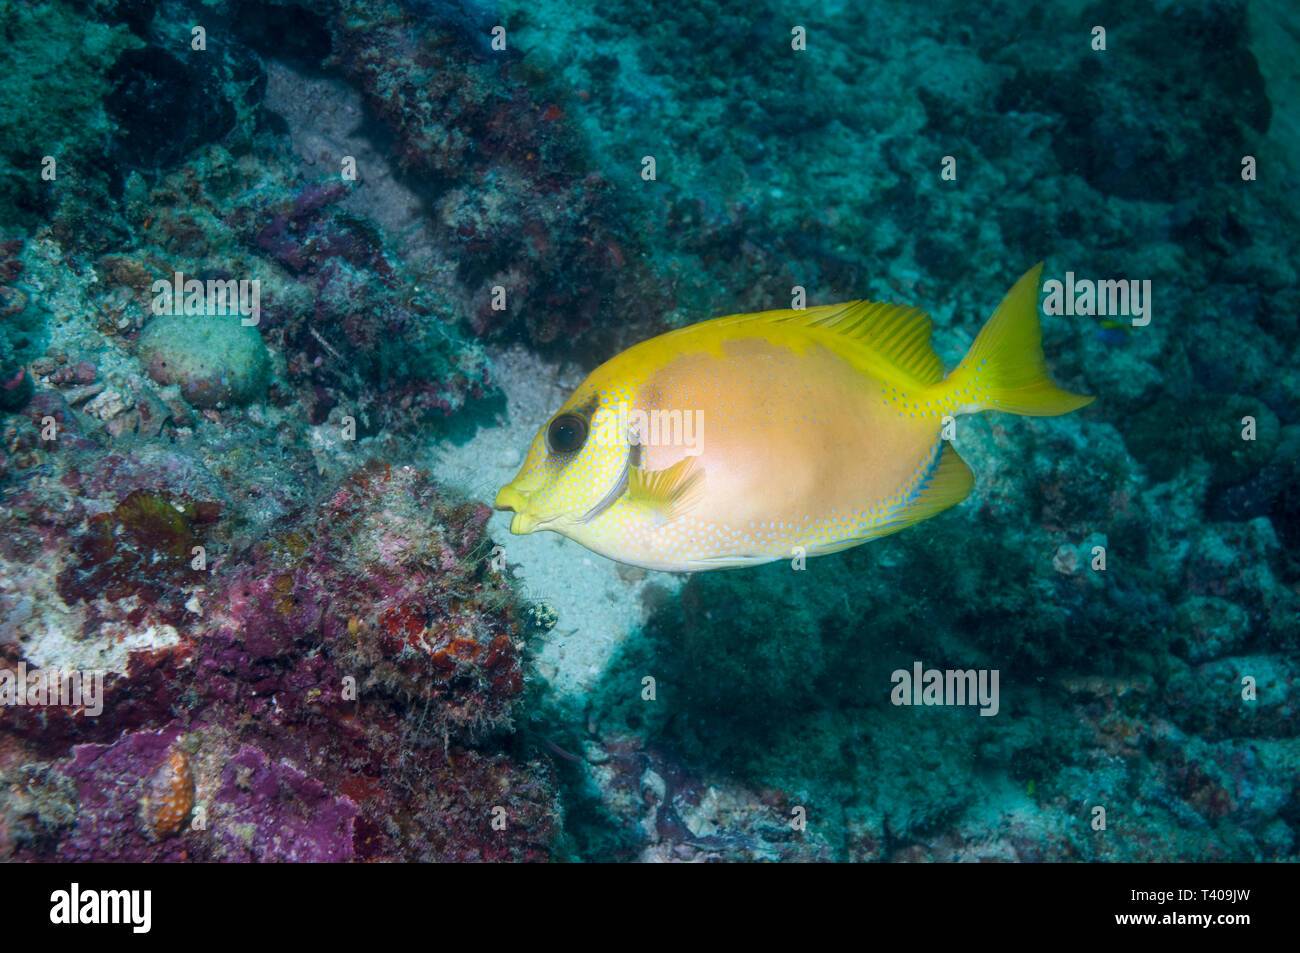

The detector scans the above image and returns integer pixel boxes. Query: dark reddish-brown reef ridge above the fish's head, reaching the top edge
[330,0,670,346]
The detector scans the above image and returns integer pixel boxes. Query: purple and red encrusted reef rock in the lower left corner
[4,467,559,861]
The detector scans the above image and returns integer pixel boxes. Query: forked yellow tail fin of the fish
[939,261,1095,417]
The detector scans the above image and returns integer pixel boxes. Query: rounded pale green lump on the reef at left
[139,315,270,407]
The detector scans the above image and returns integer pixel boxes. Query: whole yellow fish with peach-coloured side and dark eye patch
[495,263,1092,572]
